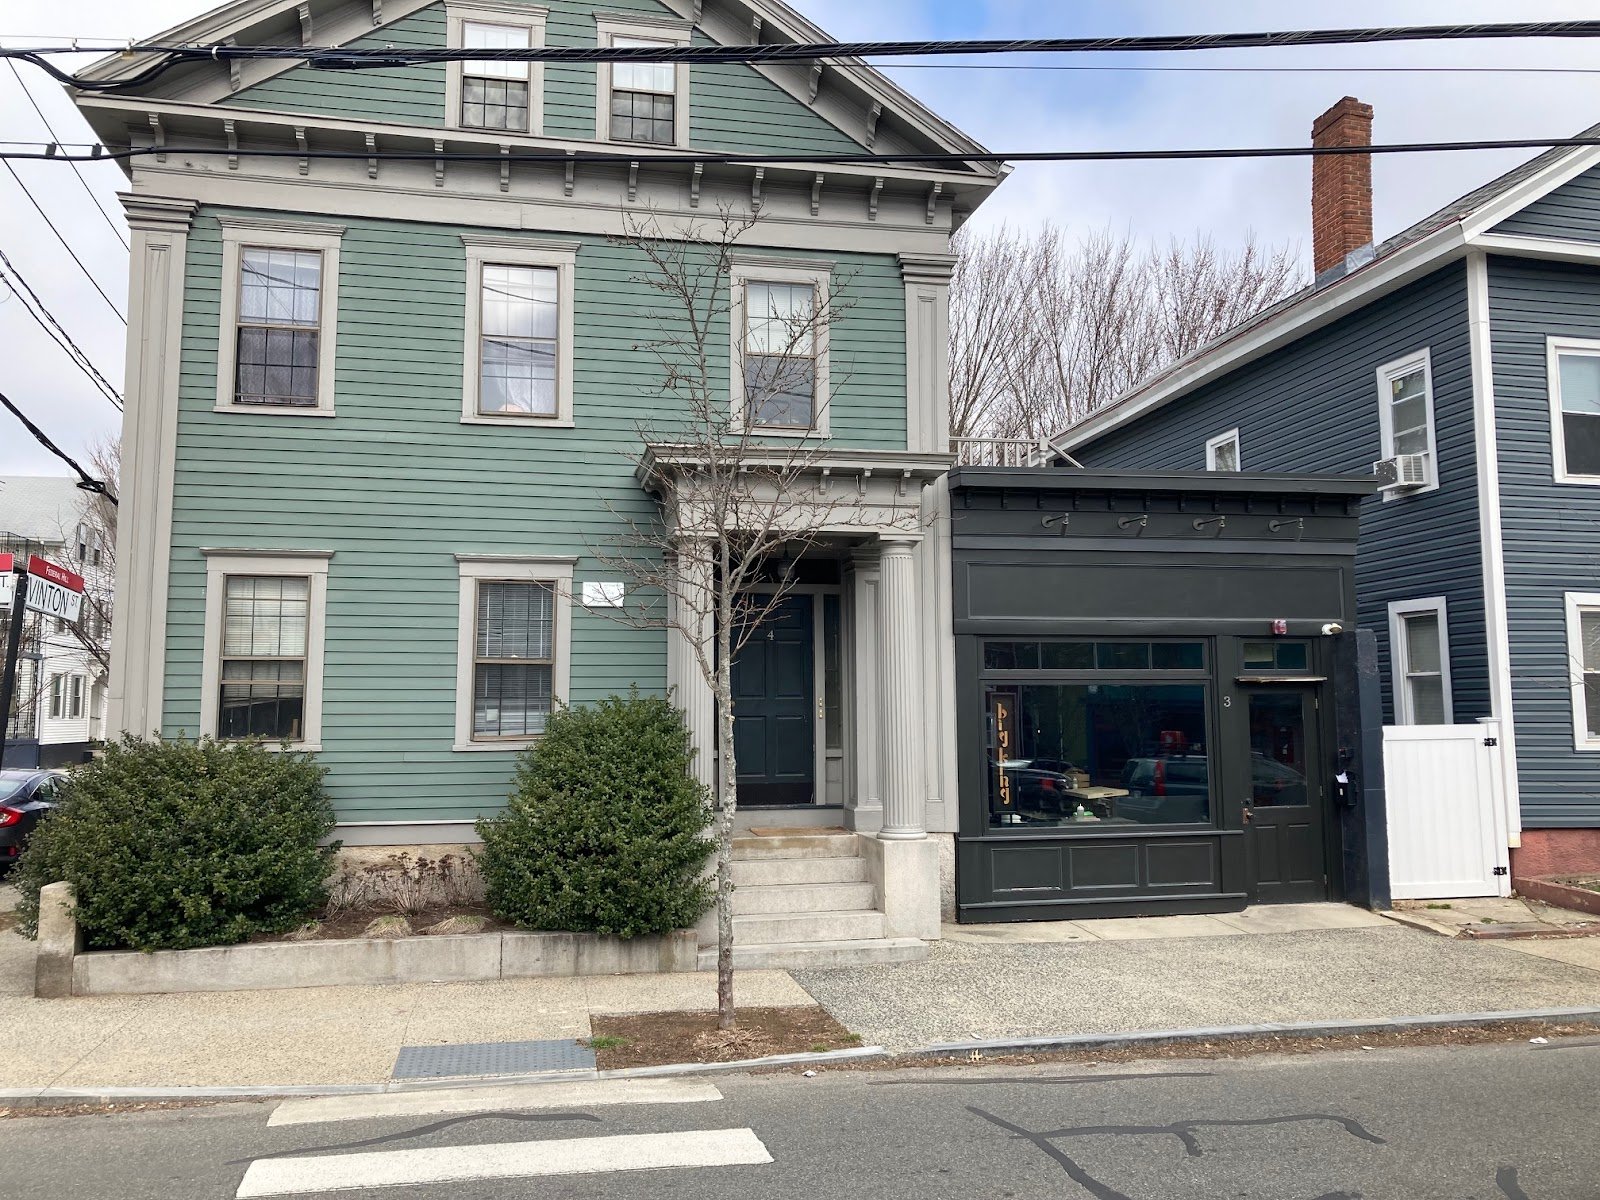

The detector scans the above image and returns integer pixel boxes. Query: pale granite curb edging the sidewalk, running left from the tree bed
[0,1046,893,1109]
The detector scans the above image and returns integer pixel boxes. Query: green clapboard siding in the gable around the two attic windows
[222,0,862,154]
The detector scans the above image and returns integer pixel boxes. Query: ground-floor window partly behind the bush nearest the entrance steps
[456,557,574,750]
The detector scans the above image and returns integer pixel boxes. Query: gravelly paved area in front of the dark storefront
[795,925,1600,1050]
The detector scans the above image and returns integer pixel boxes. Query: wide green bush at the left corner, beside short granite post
[16,738,336,950]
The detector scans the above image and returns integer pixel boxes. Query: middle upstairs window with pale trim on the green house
[462,238,578,426]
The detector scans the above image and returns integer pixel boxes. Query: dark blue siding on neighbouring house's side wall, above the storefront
[1074,266,1490,722]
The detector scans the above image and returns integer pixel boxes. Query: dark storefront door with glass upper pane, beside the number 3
[1245,685,1328,904]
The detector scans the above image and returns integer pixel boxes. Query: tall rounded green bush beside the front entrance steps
[478,690,712,938]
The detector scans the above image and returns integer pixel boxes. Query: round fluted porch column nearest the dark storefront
[878,536,928,842]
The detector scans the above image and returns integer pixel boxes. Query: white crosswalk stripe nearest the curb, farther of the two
[267,1078,722,1126]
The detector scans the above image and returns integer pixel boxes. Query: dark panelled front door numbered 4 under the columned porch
[733,595,816,806]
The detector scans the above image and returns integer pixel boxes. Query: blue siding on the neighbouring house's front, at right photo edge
[1490,258,1600,829]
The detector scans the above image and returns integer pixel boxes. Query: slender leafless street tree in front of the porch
[595,210,921,1030]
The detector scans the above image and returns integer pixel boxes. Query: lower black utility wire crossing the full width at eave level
[9,136,1600,166]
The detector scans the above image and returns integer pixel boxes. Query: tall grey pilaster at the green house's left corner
[107,195,197,736]
